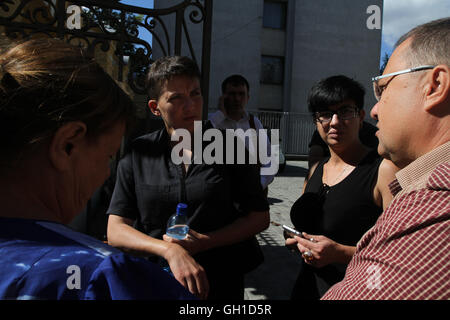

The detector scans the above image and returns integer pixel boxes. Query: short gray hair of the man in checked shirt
[395,17,450,67]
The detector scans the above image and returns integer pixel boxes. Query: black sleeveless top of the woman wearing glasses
[291,150,383,298]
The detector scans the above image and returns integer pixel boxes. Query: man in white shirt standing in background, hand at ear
[208,75,274,195]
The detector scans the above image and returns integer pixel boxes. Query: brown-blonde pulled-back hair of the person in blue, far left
[0,38,134,162]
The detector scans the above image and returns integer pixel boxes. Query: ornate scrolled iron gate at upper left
[0,0,212,114]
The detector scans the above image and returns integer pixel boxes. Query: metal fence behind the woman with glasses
[209,110,316,156]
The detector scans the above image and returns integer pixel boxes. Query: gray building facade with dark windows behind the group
[154,0,383,113]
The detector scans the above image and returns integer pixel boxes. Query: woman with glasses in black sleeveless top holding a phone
[286,76,397,299]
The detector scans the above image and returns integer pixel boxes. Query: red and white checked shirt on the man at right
[322,142,450,300]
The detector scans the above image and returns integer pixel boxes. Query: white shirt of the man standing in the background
[208,110,274,189]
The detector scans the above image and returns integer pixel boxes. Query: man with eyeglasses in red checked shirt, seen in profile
[322,18,450,300]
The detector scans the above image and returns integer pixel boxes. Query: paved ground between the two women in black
[245,161,308,300]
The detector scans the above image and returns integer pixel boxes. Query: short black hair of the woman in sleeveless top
[308,75,366,113]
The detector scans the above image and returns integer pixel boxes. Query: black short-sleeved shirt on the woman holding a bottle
[108,122,269,273]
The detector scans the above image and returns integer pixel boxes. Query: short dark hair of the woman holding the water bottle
[146,56,201,100]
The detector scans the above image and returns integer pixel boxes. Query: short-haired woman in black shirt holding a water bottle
[108,56,270,300]
